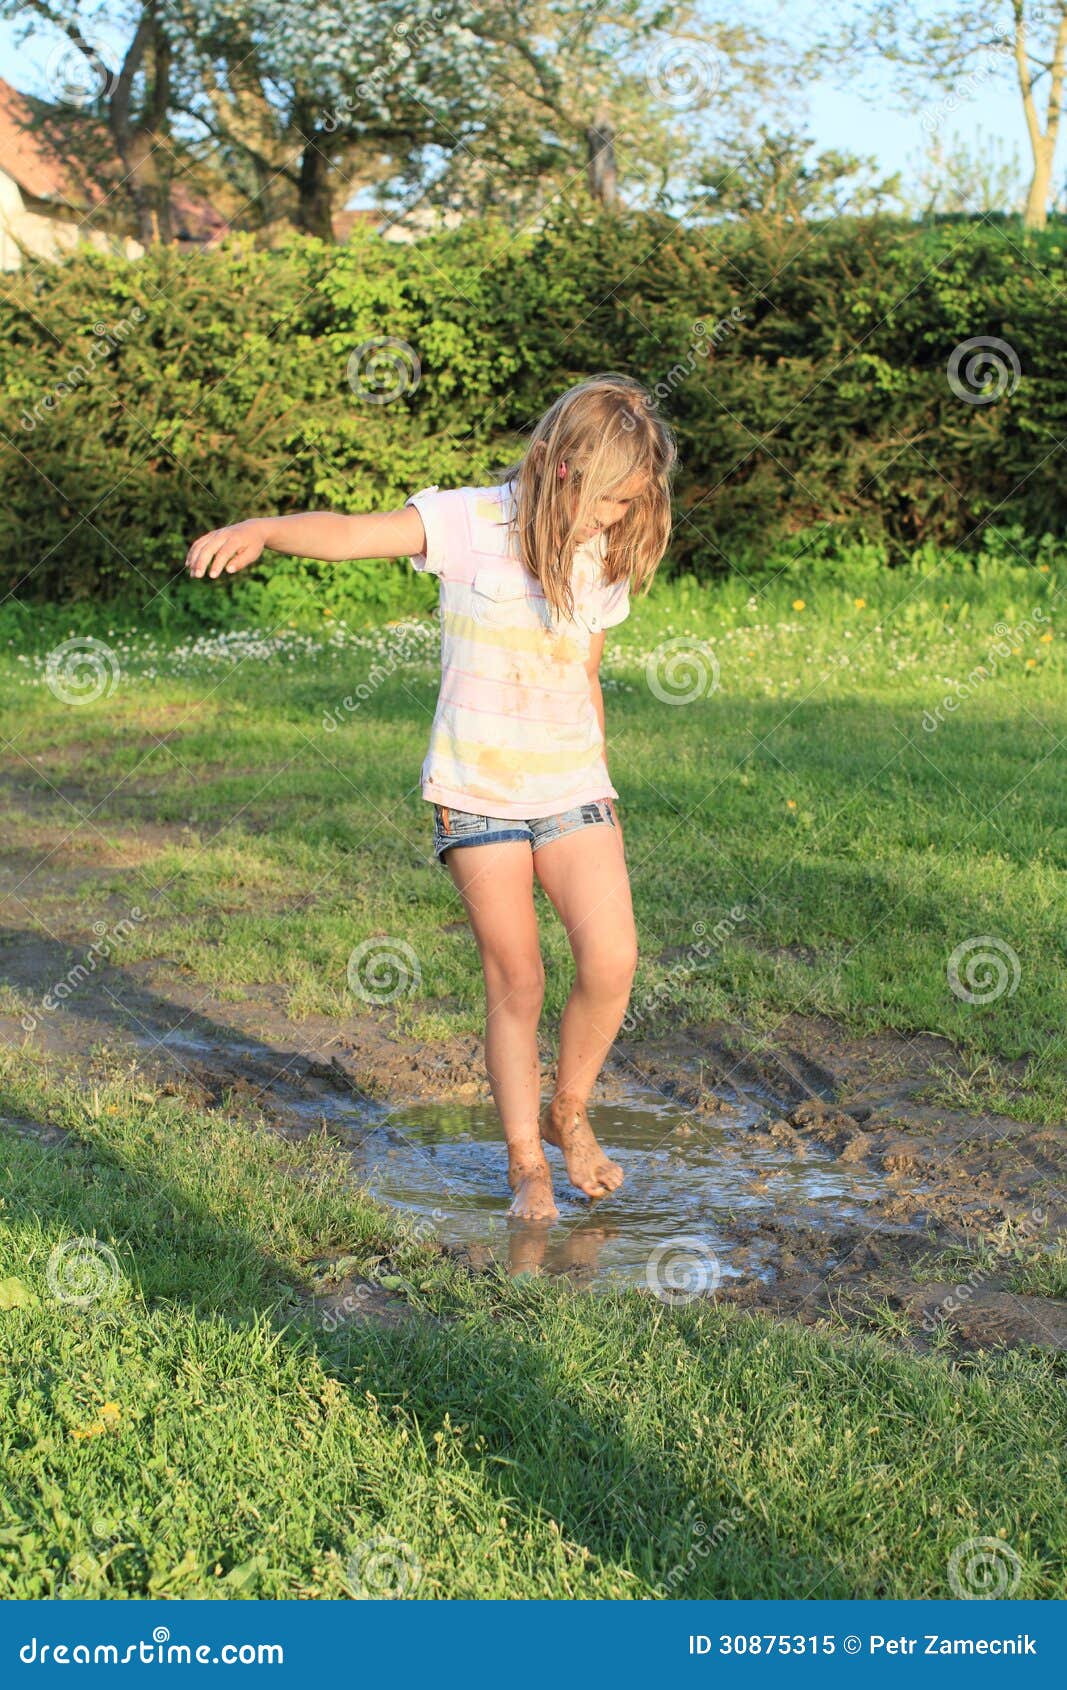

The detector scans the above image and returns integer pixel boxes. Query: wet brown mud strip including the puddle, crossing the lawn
[0,794,1067,1352]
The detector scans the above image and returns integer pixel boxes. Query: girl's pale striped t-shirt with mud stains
[404,483,629,820]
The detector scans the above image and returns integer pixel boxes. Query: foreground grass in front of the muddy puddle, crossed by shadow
[0,1053,1067,1599]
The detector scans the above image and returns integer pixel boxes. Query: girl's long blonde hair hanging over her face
[494,373,678,617]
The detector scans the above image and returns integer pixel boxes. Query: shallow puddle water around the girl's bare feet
[333,1093,881,1289]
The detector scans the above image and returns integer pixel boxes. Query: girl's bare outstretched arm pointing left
[186,505,426,580]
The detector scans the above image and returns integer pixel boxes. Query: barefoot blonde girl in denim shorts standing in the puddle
[186,375,676,1220]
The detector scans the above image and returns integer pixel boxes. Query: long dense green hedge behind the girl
[0,201,1067,622]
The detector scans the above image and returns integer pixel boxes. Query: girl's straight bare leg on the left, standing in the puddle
[445,840,560,1220]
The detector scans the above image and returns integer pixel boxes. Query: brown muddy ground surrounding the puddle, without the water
[0,797,1067,1352]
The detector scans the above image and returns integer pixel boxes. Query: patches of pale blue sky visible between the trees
[0,7,1041,214]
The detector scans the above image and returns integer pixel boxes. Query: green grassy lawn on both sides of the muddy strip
[0,540,1067,1597]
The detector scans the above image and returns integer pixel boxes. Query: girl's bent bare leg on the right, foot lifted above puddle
[534,825,637,1197]
